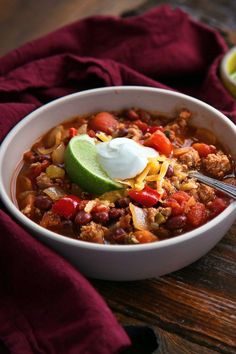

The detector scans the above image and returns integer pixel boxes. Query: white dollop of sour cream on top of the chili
[96,138,159,180]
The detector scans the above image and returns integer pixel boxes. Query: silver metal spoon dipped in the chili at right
[189,171,236,199]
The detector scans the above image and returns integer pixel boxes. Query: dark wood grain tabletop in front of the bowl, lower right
[93,223,236,354]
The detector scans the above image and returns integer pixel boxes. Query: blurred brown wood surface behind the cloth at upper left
[0,0,143,55]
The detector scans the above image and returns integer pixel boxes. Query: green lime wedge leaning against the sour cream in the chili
[65,134,122,194]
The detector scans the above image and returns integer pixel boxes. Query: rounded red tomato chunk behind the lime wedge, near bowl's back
[89,112,118,134]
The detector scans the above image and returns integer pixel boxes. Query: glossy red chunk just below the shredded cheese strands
[128,186,161,208]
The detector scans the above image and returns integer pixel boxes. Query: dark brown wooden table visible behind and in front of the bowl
[0,0,236,354]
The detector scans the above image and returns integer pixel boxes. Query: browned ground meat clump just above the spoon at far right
[202,151,231,178]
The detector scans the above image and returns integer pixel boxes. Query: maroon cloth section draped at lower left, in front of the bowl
[0,211,129,354]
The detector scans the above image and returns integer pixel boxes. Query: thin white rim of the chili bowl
[0,86,236,252]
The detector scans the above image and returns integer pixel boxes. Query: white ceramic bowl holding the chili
[0,86,236,280]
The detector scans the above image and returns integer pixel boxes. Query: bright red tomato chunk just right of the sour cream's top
[144,130,173,156]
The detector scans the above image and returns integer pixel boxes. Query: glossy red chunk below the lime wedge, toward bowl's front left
[52,195,80,219]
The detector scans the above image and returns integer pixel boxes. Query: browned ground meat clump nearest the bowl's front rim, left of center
[79,221,108,243]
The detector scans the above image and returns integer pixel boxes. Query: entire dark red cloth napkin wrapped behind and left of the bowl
[0,6,236,354]
